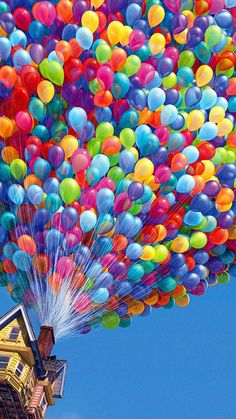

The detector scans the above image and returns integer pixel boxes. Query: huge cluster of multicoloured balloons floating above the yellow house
[0,0,236,333]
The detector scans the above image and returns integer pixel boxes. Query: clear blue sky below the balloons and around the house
[0,281,236,419]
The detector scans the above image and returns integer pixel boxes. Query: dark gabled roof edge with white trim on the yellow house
[0,304,45,378]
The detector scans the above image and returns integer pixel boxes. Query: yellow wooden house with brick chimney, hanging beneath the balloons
[0,304,67,419]
